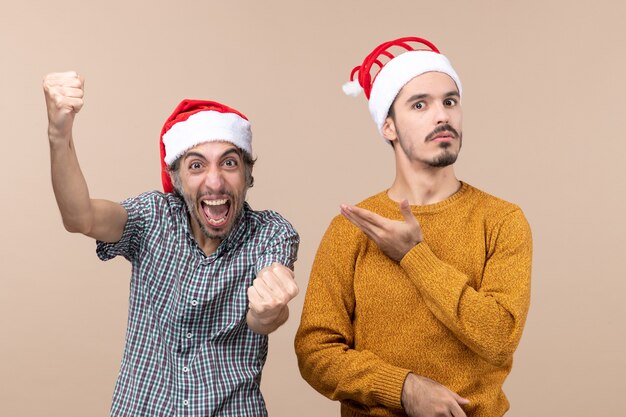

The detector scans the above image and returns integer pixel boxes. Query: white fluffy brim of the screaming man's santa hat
[163,110,252,165]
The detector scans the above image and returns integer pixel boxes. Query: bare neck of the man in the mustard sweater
[388,151,461,206]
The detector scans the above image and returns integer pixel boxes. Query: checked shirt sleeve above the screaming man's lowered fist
[256,215,300,273]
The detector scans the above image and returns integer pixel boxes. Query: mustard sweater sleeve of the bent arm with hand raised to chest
[400,209,532,366]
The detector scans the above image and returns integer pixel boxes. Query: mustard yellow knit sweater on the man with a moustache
[295,183,532,417]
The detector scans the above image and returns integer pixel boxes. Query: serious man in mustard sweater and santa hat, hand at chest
[295,38,532,417]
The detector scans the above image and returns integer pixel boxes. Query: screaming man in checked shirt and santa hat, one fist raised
[44,72,299,417]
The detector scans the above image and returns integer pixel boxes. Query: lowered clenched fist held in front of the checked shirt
[247,263,299,334]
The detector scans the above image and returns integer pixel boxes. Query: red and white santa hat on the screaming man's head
[160,99,252,193]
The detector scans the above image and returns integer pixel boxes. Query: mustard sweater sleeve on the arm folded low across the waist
[295,217,410,415]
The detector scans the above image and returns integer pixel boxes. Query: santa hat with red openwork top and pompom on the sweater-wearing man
[343,37,462,134]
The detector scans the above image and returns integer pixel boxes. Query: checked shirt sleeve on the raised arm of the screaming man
[96,193,153,261]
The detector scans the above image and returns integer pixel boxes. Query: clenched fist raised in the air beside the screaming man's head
[43,71,84,140]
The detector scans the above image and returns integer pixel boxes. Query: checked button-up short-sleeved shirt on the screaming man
[97,191,299,417]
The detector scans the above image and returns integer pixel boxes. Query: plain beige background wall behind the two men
[0,0,626,417]
